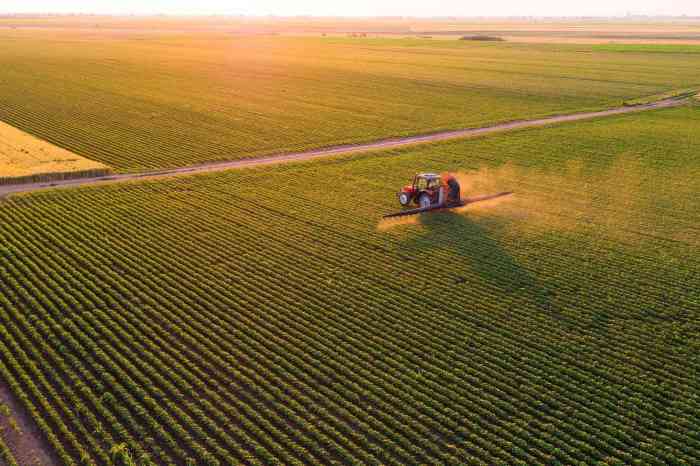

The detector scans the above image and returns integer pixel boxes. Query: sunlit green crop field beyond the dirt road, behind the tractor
[0,26,700,171]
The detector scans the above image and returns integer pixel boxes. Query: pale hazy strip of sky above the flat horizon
[0,0,700,16]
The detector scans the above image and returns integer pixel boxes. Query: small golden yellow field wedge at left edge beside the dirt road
[0,122,109,184]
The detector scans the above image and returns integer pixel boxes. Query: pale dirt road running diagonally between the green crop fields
[0,98,688,199]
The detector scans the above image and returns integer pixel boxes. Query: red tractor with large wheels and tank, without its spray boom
[399,173,462,209]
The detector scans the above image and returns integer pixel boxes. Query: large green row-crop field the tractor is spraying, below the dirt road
[0,106,700,465]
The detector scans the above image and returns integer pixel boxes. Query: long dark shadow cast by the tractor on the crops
[404,211,556,314]
